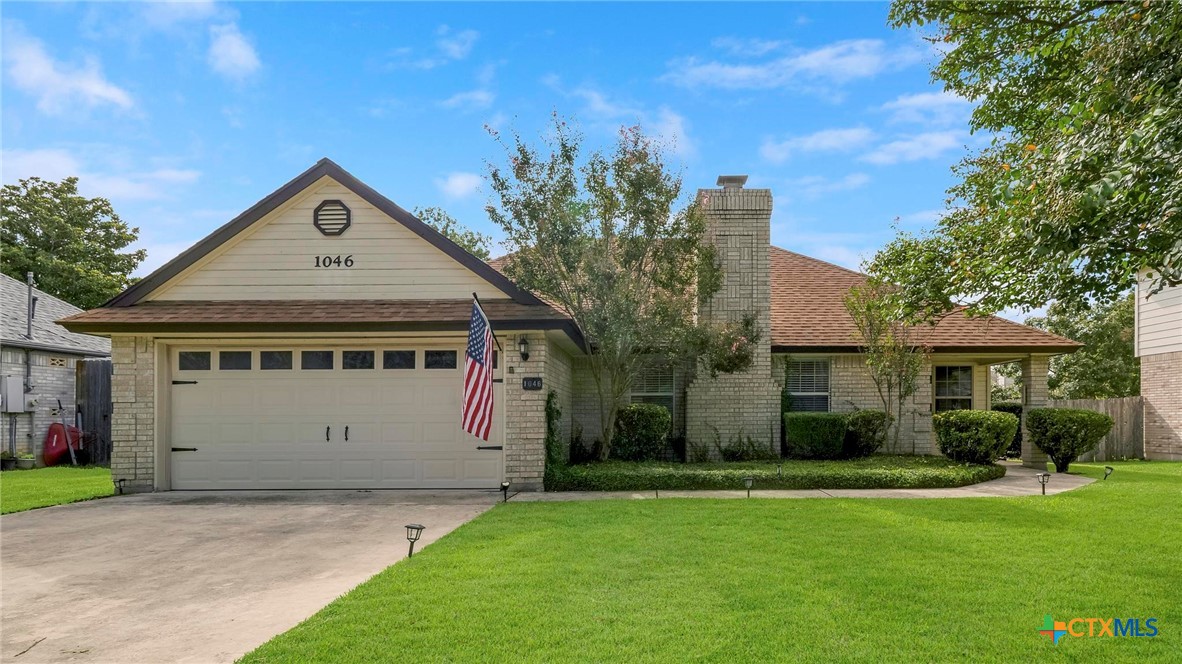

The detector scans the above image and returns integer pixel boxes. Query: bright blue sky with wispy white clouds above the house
[2,2,987,295]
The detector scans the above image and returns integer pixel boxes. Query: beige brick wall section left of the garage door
[111,337,156,490]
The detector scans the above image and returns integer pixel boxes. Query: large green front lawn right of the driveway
[243,462,1182,663]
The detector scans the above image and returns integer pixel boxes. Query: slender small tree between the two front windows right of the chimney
[845,279,930,454]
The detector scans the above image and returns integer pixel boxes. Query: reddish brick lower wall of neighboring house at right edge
[1141,351,1182,461]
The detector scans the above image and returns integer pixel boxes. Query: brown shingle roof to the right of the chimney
[771,247,1082,352]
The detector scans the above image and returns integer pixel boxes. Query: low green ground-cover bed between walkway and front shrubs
[546,455,1006,492]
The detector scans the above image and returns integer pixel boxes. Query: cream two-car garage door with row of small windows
[169,344,504,489]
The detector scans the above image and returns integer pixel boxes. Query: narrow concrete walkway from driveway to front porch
[509,462,1095,502]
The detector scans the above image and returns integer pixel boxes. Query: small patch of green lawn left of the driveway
[0,466,115,514]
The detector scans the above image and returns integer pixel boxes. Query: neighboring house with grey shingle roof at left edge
[0,274,111,458]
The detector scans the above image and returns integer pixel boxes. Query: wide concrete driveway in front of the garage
[0,492,500,663]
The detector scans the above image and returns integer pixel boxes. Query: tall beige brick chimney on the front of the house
[686,189,780,454]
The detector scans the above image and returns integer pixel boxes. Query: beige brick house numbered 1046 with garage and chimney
[61,160,1078,489]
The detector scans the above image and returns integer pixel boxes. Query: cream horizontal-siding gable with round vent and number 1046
[147,176,506,300]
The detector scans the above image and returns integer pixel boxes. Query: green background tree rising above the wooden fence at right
[1026,293,1141,399]
